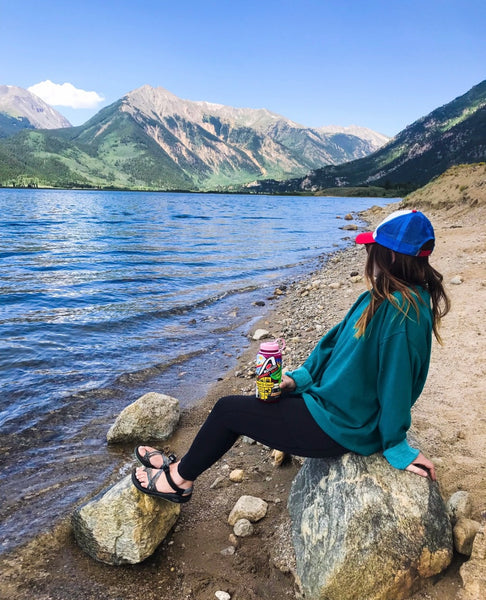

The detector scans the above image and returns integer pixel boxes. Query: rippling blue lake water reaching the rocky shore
[0,189,390,551]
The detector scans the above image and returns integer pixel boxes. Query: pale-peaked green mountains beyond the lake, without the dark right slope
[0,85,389,191]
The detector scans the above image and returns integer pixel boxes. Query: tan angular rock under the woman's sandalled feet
[71,475,181,565]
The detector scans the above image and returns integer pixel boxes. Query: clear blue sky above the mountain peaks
[0,0,486,136]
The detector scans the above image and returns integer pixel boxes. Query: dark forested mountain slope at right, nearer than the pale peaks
[251,80,486,194]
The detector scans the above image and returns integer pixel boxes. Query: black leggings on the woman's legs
[179,394,348,481]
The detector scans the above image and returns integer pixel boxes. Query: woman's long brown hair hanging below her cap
[355,242,450,343]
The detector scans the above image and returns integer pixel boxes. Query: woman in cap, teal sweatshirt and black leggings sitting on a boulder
[132,210,449,502]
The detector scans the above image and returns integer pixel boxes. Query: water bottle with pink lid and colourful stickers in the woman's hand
[256,339,285,402]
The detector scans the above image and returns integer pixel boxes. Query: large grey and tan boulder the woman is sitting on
[289,453,453,600]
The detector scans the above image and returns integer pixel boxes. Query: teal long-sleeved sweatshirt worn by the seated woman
[287,288,433,469]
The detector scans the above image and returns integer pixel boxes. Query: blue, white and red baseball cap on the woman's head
[356,210,435,256]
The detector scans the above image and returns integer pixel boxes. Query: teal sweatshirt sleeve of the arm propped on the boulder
[378,332,421,469]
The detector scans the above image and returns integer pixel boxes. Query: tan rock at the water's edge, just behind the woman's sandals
[106,392,180,444]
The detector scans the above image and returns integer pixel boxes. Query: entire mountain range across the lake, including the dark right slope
[0,81,486,195]
